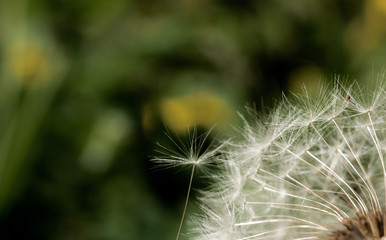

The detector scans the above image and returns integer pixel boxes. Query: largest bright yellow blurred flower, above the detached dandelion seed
[160,93,231,133]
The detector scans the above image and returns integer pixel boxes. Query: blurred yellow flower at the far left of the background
[9,41,51,85]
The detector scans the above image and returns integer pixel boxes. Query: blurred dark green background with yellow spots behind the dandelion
[0,0,386,240]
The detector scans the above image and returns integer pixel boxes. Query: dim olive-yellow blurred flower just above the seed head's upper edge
[288,66,323,96]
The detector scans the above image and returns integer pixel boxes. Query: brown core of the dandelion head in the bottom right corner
[327,212,386,240]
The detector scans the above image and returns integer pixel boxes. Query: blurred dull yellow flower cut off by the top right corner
[345,0,386,52]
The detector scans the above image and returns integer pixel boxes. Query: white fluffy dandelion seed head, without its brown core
[193,80,386,240]
